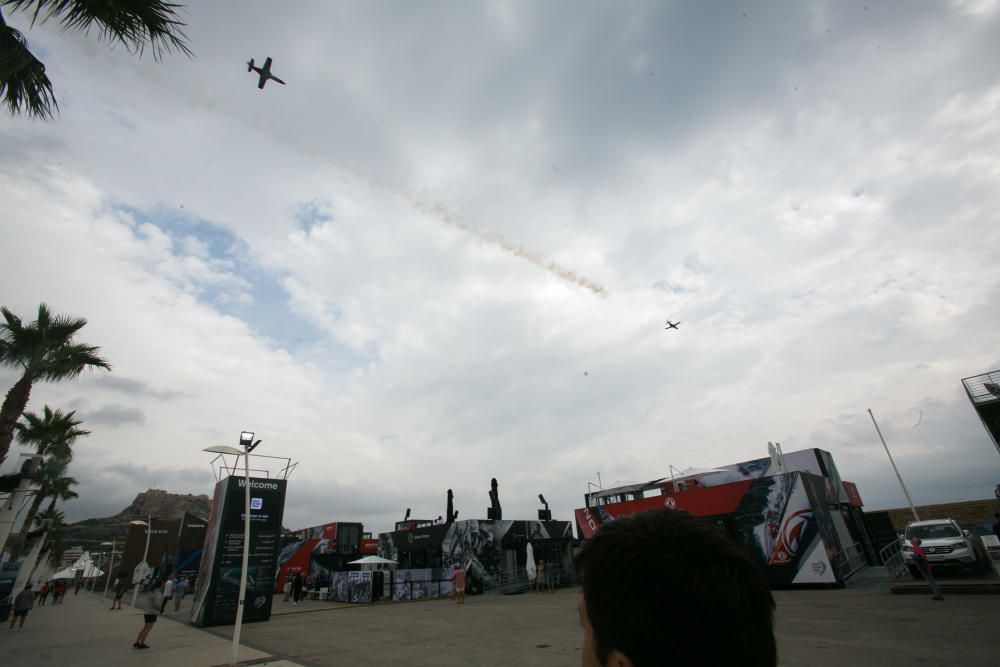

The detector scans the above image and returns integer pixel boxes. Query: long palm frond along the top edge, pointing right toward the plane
[2,0,193,60]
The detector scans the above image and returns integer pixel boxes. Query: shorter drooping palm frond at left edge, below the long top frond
[0,22,59,119]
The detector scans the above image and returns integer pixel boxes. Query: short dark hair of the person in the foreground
[577,509,777,667]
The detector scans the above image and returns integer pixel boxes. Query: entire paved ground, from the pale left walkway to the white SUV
[0,588,1000,667]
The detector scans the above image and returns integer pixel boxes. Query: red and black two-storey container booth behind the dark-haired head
[575,449,876,587]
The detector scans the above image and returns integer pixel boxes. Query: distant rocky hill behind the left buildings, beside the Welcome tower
[63,489,212,549]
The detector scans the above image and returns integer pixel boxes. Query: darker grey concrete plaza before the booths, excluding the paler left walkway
[227,586,1000,667]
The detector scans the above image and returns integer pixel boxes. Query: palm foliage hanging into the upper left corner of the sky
[0,0,192,118]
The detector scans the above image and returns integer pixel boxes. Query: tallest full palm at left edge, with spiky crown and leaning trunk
[0,303,111,463]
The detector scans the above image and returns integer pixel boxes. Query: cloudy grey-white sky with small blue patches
[0,0,1000,532]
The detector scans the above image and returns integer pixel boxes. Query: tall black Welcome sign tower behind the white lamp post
[191,476,286,626]
